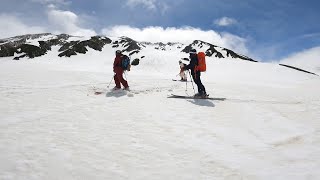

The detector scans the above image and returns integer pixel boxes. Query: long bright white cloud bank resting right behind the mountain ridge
[102,25,248,55]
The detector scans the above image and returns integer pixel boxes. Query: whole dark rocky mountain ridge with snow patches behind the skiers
[0,33,255,61]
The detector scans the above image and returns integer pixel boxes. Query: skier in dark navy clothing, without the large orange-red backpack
[183,49,208,97]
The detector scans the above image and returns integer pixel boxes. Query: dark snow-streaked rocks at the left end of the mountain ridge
[0,33,112,60]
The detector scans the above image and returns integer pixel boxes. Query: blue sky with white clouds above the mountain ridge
[0,0,320,61]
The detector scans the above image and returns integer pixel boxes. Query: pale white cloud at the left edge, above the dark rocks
[0,14,47,38]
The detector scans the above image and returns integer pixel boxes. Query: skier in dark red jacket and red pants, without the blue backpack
[113,50,129,90]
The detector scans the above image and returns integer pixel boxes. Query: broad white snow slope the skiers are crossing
[0,47,320,180]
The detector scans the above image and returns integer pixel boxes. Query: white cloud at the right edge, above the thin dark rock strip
[279,46,320,74]
